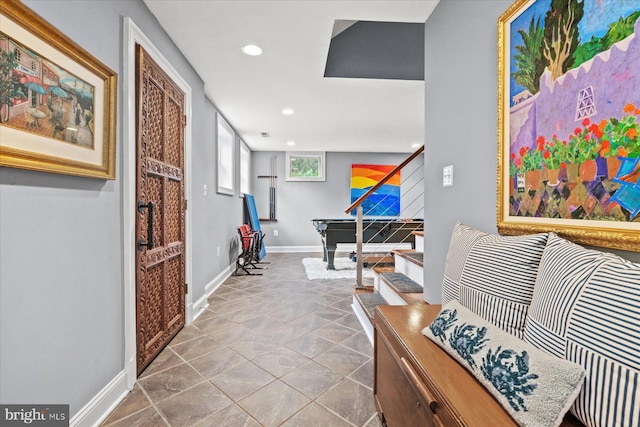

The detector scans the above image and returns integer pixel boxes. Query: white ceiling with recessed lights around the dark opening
[145,0,437,152]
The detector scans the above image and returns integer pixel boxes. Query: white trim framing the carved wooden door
[120,17,193,389]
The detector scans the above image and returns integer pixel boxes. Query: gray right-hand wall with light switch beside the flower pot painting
[424,0,640,303]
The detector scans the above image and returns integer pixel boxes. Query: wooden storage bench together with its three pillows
[375,223,640,427]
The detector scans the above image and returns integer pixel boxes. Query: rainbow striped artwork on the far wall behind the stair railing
[351,164,400,216]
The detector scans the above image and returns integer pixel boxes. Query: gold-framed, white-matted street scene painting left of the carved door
[0,0,117,179]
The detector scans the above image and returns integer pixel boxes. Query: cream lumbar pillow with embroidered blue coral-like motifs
[422,301,584,427]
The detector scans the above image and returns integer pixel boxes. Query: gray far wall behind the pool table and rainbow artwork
[251,152,423,248]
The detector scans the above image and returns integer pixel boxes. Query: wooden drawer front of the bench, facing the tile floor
[375,330,440,427]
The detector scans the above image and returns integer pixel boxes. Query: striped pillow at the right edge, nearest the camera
[524,233,640,427]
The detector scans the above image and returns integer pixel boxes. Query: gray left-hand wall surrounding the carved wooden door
[0,0,242,416]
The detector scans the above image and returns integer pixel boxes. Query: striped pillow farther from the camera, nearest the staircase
[442,223,547,338]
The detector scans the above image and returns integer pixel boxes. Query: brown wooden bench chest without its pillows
[373,304,582,427]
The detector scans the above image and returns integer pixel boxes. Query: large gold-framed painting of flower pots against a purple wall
[497,0,640,251]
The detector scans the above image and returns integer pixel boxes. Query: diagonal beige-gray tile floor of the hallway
[103,254,381,427]
